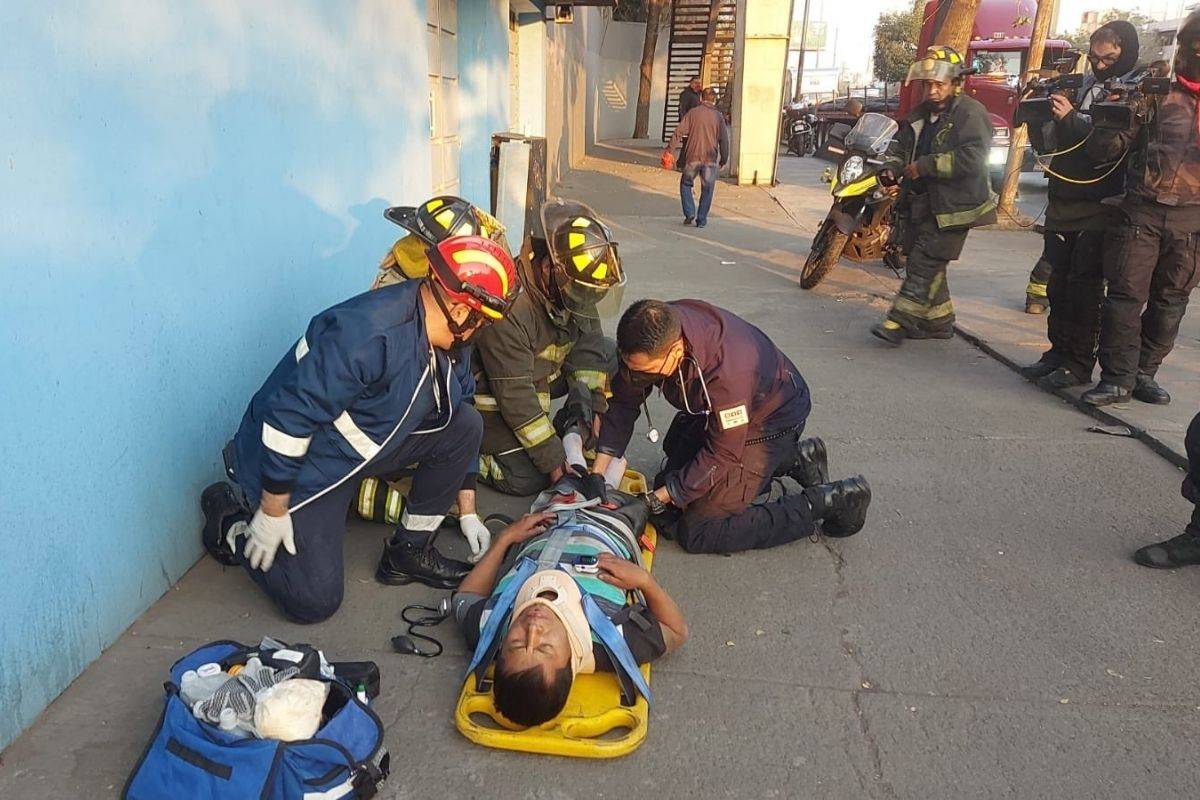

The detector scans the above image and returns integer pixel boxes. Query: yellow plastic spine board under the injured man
[455,470,658,758]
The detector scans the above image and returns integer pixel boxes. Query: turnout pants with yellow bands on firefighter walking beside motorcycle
[883,206,968,338]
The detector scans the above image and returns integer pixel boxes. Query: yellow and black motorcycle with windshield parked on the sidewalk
[800,113,900,289]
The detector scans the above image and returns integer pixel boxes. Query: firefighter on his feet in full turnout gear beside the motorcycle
[871,44,996,344]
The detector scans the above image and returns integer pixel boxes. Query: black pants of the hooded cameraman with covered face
[1042,230,1104,380]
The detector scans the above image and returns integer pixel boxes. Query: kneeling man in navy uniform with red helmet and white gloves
[200,236,517,622]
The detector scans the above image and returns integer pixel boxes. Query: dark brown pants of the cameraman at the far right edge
[1099,203,1200,389]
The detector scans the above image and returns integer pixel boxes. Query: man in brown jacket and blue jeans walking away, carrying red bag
[664,86,730,228]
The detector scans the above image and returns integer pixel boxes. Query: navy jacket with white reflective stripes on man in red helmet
[234,281,475,511]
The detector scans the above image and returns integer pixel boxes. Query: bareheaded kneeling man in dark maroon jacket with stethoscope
[590,300,871,553]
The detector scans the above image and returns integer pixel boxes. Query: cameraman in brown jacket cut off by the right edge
[1082,12,1200,405]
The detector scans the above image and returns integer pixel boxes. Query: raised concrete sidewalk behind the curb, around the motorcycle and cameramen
[768,155,1200,465]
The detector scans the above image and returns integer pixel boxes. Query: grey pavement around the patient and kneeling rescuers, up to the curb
[0,148,1200,799]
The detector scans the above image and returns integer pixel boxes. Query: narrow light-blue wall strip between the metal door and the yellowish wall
[458,0,518,209]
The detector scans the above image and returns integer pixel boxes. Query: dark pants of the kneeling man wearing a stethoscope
[654,411,816,553]
